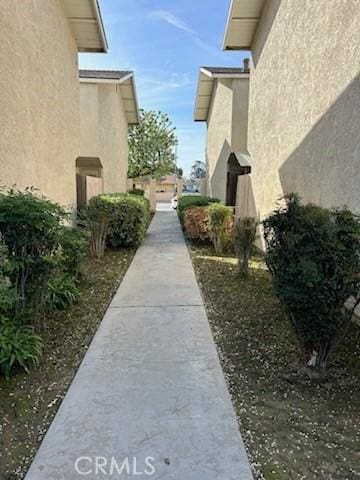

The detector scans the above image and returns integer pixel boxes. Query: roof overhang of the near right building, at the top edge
[223,0,266,50]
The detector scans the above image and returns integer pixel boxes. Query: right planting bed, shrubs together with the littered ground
[184,194,360,480]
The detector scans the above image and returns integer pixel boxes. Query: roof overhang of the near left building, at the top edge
[63,0,108,53]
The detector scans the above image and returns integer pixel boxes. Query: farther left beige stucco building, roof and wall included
[76,70,139,205]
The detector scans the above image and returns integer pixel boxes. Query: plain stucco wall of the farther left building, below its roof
[80,83,128,193]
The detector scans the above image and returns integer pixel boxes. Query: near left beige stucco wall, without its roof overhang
[0,0,79,210]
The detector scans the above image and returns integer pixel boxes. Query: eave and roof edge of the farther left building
[79,70,139,125]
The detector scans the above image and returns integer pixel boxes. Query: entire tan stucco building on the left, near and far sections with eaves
[0,0,138,208]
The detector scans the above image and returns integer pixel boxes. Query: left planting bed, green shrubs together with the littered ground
[0,188,150,480]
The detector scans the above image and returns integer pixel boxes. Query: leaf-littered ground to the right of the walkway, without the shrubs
[190,246,360,480]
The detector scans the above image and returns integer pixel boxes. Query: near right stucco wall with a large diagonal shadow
[248,0,360,217]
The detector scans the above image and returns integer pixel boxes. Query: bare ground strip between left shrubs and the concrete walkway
[0,250,135,480]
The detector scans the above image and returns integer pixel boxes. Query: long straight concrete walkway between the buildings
[26,207,252,480]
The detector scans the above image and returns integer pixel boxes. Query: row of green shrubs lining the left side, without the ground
[0,189,150,377]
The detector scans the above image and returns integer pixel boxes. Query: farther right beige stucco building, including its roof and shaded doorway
[194,62,249,205]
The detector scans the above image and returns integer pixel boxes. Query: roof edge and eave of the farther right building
[194,67,250,122]
